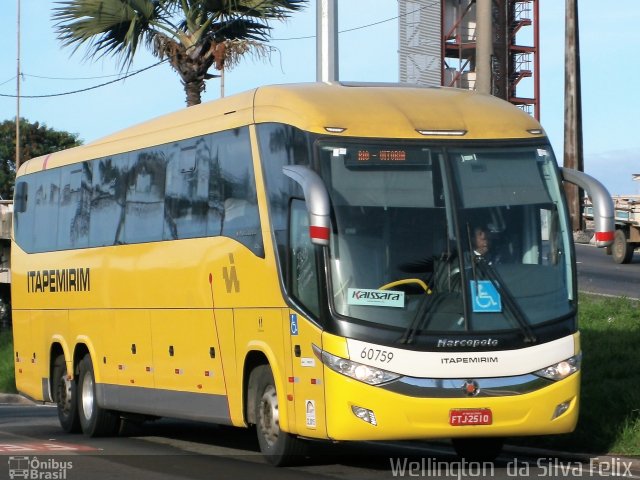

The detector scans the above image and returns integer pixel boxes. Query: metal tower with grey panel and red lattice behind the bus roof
[398,0,540,119]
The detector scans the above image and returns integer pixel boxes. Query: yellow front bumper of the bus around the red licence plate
[325,368,580,440]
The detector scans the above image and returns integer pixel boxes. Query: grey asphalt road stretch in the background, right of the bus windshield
[576,244,640,298]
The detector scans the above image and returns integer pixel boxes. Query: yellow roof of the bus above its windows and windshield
[19,83,544,175]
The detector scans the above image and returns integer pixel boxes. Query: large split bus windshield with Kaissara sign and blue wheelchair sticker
[317,140,574,336]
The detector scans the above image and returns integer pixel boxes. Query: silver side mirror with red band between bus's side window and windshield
[282,165,331,246]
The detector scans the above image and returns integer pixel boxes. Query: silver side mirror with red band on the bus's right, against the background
[562,168,615,247]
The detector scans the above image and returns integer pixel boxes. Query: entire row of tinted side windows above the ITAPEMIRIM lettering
[15,127,264,256]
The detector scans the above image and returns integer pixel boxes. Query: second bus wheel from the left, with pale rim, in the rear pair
[78,355,120,437]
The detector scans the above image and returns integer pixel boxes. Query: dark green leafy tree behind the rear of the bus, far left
[0,118,82,199]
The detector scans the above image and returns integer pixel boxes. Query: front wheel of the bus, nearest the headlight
[249,365,306,466]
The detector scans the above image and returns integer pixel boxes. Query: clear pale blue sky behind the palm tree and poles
[0,0,640,195]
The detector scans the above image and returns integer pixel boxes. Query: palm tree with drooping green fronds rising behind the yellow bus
[53,0,307,106]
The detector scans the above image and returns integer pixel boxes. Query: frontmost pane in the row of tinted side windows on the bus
[215,127,264,256]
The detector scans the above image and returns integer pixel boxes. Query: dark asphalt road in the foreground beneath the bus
[0,405,640,480]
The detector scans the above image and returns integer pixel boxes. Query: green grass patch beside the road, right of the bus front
[517,295,640,455]
